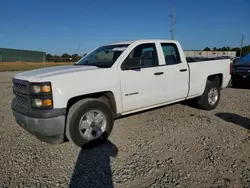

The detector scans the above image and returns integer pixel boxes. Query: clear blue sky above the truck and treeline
[0,0,250,55]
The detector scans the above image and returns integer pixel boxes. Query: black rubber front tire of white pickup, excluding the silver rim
[66,99,114,148]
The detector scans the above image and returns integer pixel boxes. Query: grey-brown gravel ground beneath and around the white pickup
[0,72,250,188]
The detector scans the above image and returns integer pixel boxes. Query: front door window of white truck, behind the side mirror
[121,43,158,70]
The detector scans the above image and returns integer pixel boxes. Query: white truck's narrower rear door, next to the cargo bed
[159,43,189,102]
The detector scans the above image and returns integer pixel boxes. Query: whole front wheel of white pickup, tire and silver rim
[66,99,114,147]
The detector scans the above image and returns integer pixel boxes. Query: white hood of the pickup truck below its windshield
[14,65,98,82]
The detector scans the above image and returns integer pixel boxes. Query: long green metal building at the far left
[0,48,46,62]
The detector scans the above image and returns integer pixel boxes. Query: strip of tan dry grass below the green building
[0,62,74,71]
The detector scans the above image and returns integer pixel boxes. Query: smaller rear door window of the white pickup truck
[161,43,181,65]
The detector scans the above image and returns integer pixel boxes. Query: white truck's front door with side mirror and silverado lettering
[120,43,166,113]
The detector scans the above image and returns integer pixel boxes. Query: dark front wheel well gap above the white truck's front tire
[67,91,117,116]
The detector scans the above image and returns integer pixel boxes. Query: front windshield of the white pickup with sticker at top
[75,44,128,68]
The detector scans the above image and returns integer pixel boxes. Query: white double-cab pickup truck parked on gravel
[12,40,231,147]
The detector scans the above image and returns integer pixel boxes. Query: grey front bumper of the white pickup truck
[12,99,66,144]
